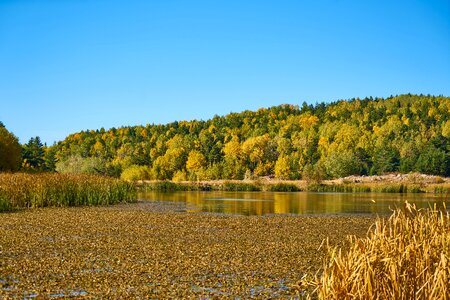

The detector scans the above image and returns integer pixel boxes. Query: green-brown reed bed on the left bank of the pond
[0,173,136,211]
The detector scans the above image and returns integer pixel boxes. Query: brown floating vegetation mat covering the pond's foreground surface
[0,201,374,299]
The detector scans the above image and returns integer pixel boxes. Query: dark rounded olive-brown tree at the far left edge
[0,122,21,172]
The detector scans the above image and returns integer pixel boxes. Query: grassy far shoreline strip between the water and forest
[136,173,450,194]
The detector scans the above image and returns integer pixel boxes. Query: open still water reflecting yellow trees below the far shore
[139,191,450,215]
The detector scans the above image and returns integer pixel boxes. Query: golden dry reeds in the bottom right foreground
[313,204,450,299]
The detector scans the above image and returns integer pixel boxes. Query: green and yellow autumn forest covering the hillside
[0,94,450,181]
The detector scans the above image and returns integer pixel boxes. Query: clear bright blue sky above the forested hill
[0,0,450,144]
